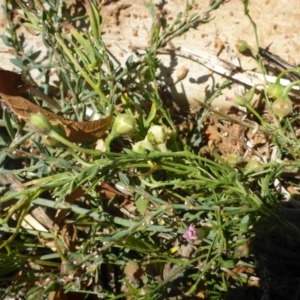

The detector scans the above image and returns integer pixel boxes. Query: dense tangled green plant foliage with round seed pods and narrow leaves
[0,0,300,300]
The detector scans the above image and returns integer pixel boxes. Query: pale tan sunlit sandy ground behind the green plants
[0,0,300,106]
